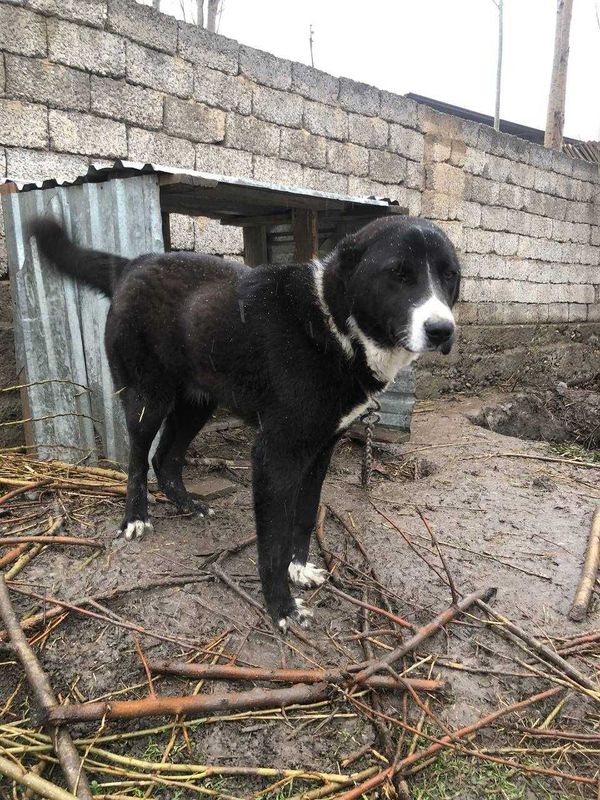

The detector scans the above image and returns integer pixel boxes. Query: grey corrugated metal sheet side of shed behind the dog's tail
[2,175,164,464]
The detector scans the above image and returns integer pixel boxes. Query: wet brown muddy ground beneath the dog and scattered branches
[0,396,600,800]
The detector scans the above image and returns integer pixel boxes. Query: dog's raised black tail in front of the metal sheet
[29,217,129,297]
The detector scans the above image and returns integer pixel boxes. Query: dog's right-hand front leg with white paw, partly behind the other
[288,440,337,587]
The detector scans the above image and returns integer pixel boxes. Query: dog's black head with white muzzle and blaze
[332,217,460,354]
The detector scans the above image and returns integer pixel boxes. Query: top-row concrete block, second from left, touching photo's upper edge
[106,0,177,53]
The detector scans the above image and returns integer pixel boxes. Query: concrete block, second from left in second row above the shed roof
[49,109,127,158]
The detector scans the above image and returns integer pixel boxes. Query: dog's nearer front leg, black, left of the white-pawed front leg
[252,433,312,632]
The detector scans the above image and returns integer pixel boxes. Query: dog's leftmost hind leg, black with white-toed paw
[119,389,165,539]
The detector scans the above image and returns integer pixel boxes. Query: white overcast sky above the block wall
[156,0,600,139]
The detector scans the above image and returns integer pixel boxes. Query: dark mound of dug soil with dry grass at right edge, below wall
[472,384,600,450]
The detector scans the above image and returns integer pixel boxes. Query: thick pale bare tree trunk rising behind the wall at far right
[544,0,573,150]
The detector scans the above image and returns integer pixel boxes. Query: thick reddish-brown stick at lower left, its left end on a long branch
[46,683,331,725]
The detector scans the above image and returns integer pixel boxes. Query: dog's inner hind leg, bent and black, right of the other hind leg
[152,398,216,516]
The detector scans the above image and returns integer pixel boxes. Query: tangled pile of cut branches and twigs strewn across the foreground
[0,454,600,800]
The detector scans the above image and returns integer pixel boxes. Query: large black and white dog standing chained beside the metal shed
[31,217,460,631]
